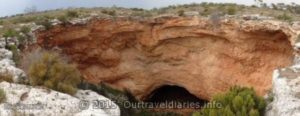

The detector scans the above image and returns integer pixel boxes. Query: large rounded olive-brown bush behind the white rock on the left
[23,50,81,95]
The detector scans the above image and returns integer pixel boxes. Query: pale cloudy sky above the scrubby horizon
[0,0,300,17]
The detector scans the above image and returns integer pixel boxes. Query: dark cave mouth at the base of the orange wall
[144,85,208,109]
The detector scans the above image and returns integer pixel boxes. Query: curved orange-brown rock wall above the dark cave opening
[36,17,295,100]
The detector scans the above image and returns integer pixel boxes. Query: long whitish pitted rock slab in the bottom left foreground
[0,82,120,116]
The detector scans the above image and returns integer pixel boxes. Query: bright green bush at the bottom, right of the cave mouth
[193,86,266,116]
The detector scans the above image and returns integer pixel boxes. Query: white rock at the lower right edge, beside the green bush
[266,66,300,116]
